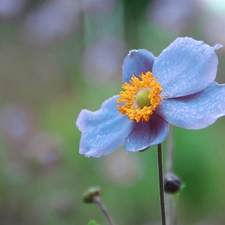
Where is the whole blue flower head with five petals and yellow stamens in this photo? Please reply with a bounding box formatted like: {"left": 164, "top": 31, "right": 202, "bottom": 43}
{"left": 76, "top": 37, "right": 225, "bottom": 157}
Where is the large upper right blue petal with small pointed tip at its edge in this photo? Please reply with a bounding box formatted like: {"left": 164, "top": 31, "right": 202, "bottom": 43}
{"left": 153, "top": 37, "right": 222, "bottom": 98}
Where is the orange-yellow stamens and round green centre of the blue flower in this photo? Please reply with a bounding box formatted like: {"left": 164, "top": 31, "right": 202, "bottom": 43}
{"left": 117, "top": 72, "right": 163, "bottom": 122}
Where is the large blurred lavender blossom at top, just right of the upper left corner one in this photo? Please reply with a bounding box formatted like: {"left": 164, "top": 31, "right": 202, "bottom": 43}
{"left": 23, "top": 0, "right": 80, "bottom": 43}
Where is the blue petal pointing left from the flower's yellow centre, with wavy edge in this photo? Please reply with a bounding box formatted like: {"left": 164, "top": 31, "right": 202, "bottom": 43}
{"left": 76, "top": 96, "right": 136, "bottom": 157}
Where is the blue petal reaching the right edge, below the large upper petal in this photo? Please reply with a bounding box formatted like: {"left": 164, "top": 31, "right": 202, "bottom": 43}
{"left": 156, "top": 82, "right": 225, "bottom": 130}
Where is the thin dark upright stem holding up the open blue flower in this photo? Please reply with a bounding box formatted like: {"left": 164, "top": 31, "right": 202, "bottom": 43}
{"left": 157, "top": 144, "right": 166, "bottom": 225}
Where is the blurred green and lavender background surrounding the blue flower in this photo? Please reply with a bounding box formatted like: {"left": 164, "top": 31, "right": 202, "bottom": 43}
{"left": 0, "top": 0, "right": 225, "bottom": 225}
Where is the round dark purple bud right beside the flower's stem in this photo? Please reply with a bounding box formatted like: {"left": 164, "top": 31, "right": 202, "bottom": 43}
{"left": 164, "top": 173, "right": 182, "bottom": 194}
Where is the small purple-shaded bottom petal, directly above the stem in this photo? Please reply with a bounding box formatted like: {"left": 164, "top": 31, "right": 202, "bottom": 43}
{"left": 125, "top": 114, "right": 169, "bottom": 152}
